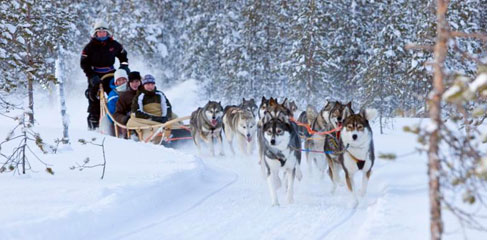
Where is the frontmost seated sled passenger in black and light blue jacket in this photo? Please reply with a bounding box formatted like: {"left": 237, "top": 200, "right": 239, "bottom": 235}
{"left": 127, "top": 74, "right": 172, "bottom": 142}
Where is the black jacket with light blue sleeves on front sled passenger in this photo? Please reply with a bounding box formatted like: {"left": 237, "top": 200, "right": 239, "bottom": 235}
{"left": 132, "top": 87, "right": 172, "bottom": 119}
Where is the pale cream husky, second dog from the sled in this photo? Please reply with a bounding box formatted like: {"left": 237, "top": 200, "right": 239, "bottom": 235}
{"left": 223, "top": 106, "right": 256, "bottom": 154}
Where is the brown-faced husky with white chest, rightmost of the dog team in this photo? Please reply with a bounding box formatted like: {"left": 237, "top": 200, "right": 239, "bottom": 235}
{"left": 342, "top": 109, "right": 377, "bottom": 205}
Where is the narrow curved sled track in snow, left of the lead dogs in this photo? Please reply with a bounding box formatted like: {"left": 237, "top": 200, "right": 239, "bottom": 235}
{"left": 113, "top": 162, "right": 240, "bottom": 239}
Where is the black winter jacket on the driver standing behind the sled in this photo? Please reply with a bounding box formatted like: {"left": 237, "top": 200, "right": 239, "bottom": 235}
{"left": 80, "top": 37, "right": 128, "bottom": 79}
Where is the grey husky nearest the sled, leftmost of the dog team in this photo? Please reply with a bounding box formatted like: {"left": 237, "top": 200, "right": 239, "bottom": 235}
{"left": 190, "top": 101, "right": 225, "bottom": 156}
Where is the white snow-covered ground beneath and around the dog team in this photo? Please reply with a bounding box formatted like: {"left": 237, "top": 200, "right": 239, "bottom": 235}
{"left": 0, "top": 81, "right": 482, "bottom": 240}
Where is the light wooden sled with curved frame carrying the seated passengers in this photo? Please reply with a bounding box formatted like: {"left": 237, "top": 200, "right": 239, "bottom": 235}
{"left": 98, "top": 73, "right": 191, "bottom": 147}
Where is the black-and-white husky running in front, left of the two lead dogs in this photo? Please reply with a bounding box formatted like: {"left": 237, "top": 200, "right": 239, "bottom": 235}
{"left": 261, "top": 112, "right": 302, "bottom": 206}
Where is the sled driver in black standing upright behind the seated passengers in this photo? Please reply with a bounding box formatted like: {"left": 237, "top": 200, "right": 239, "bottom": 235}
{"left": 80, "top": 21, "right": 130, "bottom": 130}
